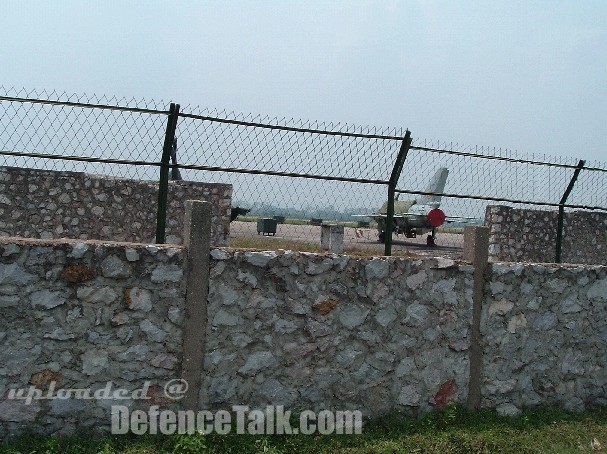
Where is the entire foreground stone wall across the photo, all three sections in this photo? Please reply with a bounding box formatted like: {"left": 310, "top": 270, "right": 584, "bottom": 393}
{"left": 0, "top": 227, "right": 607, "bottom": 437}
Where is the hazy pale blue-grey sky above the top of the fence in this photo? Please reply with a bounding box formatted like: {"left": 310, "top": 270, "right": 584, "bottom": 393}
{"left": 0, "top": 0, "right": 607, "bottom": 161}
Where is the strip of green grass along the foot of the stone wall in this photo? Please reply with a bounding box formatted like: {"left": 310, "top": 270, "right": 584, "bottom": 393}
{"left": 0, "top": 407, "right": 607, "bottom": 454}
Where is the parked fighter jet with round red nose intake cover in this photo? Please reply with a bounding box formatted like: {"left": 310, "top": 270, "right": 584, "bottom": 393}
{"left": 356, "top": 167, "right": 476, "bottom": 246}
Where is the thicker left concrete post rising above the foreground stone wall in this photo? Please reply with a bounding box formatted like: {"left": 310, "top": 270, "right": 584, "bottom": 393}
{"left": 181, "top": 200, "right": 211, "bottom": 410}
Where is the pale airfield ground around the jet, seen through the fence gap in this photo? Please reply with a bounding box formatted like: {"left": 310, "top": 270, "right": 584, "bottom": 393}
{"left": 230, "top": 221, "right": 464, "bottom": 259}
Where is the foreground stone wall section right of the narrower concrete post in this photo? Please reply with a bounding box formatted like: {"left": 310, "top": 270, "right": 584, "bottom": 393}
{"left": 481, "top": 263, "right": 607, "bottom": 412}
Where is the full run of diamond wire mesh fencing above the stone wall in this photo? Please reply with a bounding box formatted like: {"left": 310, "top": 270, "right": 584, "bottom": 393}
{"left": 0, "top": 87, "right": 607, "bottom": 257}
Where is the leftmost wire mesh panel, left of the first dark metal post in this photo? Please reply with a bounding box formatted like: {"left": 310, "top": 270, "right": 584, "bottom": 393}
{"left": 0, "top": 87, "right": 171, "bottom": 180}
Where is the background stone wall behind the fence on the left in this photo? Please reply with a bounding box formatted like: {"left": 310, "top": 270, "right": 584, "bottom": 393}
{"left": 0, "top": 167, "right": 232, "bottom": 246}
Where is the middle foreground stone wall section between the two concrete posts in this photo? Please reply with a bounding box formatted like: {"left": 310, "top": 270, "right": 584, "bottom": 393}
{"left": 202, "top": 249, "right": 472, "bottom": 416}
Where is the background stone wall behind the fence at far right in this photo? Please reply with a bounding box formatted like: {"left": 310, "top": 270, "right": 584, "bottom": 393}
{"left": 485, "top": 205, "right": 607, "bottom": 265}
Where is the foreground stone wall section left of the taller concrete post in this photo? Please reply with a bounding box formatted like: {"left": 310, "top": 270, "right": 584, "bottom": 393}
{"left": 0, "top": 238, "right": 186, "bottom": 439}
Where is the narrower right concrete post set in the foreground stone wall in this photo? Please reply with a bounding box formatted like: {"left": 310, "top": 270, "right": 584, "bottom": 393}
{"left": 464, "top": 226, "right": 489, "bottom": 410}
